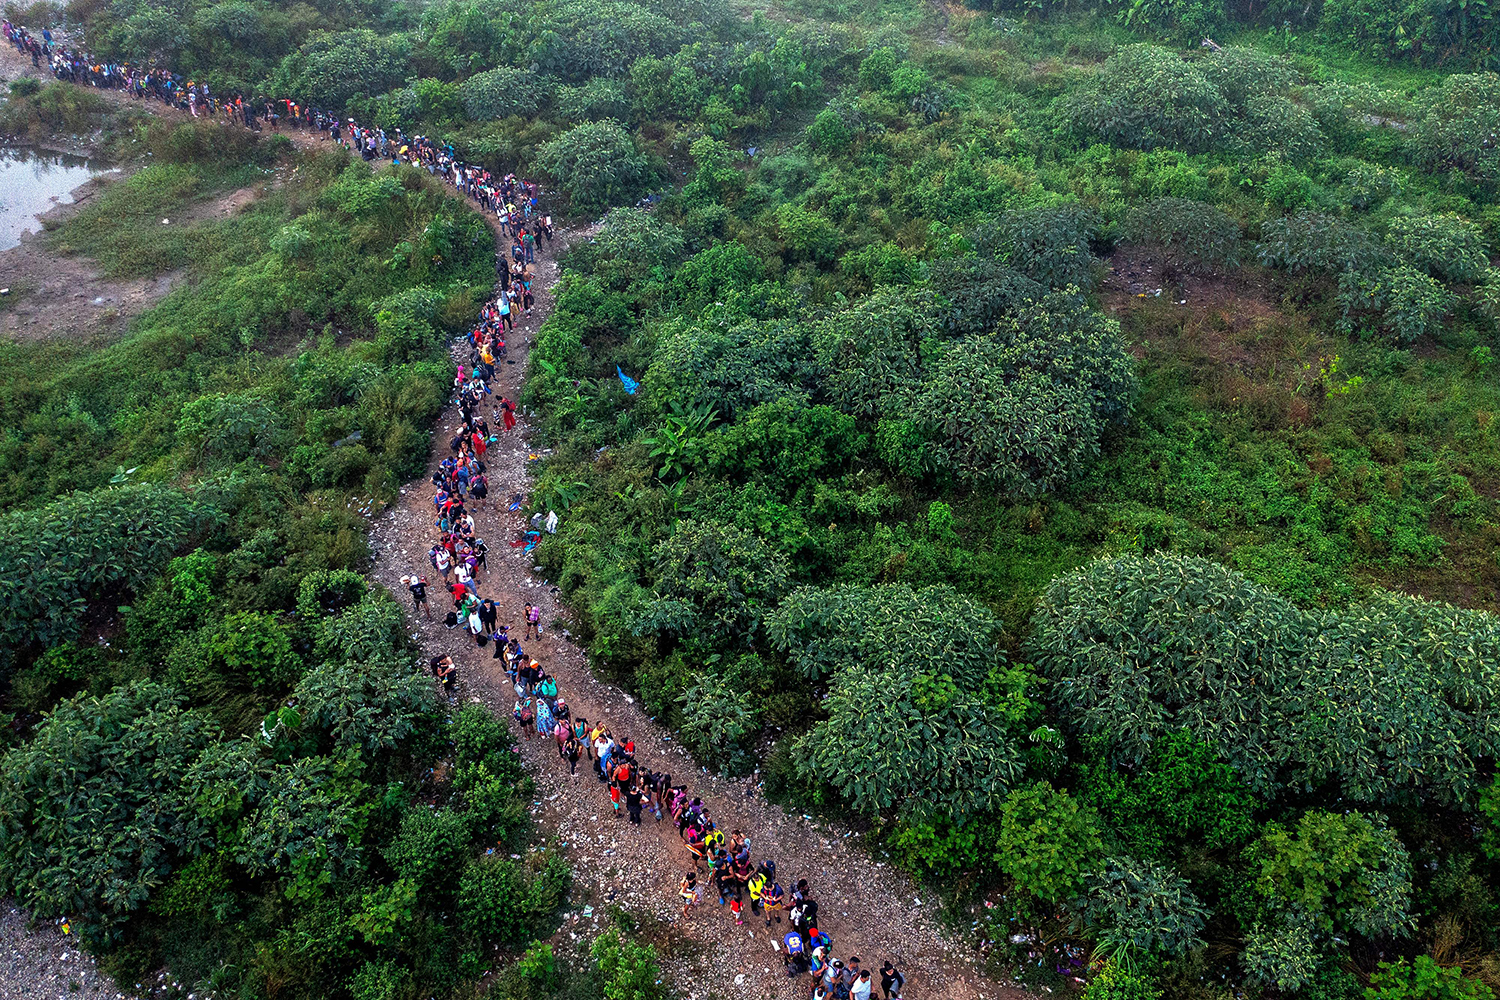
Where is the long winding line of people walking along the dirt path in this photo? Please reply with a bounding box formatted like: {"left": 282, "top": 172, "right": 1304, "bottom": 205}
{"left": 3, "top": 21, "right": 905, "bottom": 1000}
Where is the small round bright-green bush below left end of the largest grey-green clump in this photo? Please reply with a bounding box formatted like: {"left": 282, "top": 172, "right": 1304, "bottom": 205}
{"left": 995, "top": 781, "right": 1104, "bottom": 903}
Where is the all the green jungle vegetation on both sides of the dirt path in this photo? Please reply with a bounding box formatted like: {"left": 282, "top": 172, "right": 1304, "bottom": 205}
{"left": 0, "top": 0, "right": 1500, "bottom": 1000}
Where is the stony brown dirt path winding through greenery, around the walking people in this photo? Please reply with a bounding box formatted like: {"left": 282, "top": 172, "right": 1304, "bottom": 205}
{"left": 0, "top": 46, "right": 1031, "bottom": 1000}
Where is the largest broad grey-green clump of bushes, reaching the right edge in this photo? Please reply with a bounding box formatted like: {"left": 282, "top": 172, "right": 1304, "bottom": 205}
{"left": 1029, "top": 555, "right": 1500, "bottom": 805}
